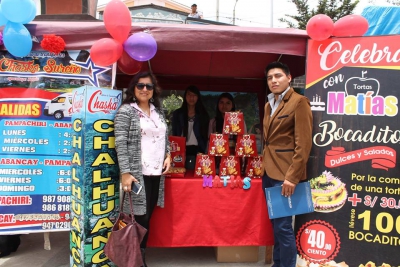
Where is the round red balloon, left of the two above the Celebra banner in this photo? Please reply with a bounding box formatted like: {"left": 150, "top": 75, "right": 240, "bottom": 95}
{"left": 306, "top": 14, "right": 333, "bottom": 41}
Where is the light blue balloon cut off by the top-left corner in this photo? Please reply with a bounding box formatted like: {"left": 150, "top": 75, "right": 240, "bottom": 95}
{"left": 1, "top": 0, "right": 36, "bottom": 23}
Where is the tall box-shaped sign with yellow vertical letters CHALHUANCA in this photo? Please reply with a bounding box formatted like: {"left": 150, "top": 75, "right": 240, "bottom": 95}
{"left": 70, "top": 86, "right": 122, "bottom": 266}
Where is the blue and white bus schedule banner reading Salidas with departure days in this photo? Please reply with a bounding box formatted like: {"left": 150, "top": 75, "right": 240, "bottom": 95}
{"left": 0, "top": 50, "right": 111, "bottom": 234}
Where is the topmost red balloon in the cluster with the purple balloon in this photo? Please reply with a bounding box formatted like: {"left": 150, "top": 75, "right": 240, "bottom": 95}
{"left": 103, "top": 0, "right": 132, "bottom": 44}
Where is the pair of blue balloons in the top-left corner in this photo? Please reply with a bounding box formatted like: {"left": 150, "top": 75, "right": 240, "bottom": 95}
{"left": 0, "top": 0, "right": 36, "bottom": 57}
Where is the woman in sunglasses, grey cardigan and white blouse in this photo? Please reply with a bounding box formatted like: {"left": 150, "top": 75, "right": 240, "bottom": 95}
{"left": 114, "top": 72, "right": 171, "bottom": 266}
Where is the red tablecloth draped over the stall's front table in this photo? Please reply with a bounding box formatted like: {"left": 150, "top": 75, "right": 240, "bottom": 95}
{"left": 148, "top": 177, "right": 273, "bottom": 247}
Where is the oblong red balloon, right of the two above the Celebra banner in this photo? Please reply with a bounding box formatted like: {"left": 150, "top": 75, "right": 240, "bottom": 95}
{"left": 333, "top": 15, "right": 369, "bottom": 37}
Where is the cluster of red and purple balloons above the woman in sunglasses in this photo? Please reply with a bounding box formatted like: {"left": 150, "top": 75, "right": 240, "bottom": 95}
{"left": 90, "top": 0, "right": 157, "bottom": 75}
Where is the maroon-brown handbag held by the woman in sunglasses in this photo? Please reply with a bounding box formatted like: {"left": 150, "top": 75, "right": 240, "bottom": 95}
{"left": 104, "top": 192, "right": 147, "bottom": 267}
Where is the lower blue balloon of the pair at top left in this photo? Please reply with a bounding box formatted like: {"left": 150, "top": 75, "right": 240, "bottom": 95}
{"left": 3, "top": 22, "right": 32, "bottom": 57}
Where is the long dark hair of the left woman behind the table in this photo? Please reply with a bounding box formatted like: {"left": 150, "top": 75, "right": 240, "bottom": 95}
{"left": 181, "top": 85, "right": 210, "bottom": 140}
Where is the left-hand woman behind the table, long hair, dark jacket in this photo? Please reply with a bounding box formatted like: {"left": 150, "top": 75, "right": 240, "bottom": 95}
{"left": 172, "top": 85, "right": 209, "bottom": 169}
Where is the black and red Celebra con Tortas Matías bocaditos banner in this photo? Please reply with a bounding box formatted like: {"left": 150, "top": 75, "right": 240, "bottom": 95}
{"left": 296, "top": 36, "right": 400, "bottom": 267}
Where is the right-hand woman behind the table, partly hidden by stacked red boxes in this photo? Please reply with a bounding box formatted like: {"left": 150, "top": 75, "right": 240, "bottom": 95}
{"left": 208, "top": 93, "right": 247, "bottom": 155}
